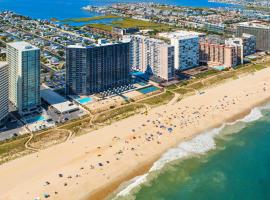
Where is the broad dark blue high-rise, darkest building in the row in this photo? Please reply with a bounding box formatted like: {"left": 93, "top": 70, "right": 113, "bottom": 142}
{"left": 66, "top": 43, "right": 130, "bottom": 95}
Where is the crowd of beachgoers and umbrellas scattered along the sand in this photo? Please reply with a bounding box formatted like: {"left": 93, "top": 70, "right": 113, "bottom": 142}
{"left": 34, "top": 83, "right": 268, "bottom": 200}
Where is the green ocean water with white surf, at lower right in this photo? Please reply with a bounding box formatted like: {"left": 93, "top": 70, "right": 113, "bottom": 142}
{"left": 112, "top": 104, "right": 270, "bottom": 200}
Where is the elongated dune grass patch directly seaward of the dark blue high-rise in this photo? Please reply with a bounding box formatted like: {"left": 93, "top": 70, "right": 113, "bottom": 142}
{"left": 93, "top": 104, "right": 144, "bottom": 123}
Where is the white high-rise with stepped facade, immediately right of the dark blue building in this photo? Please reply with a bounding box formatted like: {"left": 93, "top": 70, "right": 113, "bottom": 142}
{"left": 125, "top": 35, "right": 174, "bottom": 80}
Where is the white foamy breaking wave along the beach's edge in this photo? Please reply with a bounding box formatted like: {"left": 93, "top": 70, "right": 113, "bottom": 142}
{"left": 113, "top": 104, "right": 270, "bottom": 200}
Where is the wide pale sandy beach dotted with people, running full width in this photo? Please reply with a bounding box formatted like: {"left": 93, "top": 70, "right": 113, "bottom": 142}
{"left": 0, "top": 68, "right": 270, "bottom": 200}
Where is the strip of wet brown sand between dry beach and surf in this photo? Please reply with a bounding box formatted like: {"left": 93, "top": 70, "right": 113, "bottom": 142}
{"left": 90, "top": 97, "right": 270, "bottom": 200}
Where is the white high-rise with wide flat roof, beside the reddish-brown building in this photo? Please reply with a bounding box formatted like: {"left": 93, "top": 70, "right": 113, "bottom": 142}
{"left": 159, "top": 31, "right": 200, "bottom": 71}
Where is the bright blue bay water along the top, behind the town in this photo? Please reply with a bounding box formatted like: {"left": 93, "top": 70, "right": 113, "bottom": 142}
{"left": 0, "top": 0, "right": 231, "bottom": 20}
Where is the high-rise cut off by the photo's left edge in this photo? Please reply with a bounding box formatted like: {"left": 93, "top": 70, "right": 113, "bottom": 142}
{"left": 0, "top": 62, "right": 9, "bottom": 126}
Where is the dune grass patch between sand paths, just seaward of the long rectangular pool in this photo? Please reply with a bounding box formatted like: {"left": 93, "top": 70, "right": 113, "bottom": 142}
{"left": 140, "top": 91, "right": 174, "bottom": 106}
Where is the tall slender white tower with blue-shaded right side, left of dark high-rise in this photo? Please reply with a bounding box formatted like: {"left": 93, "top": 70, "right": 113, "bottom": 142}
{"left": 7, "top": 42, "right": 40, "bottom": 115}
